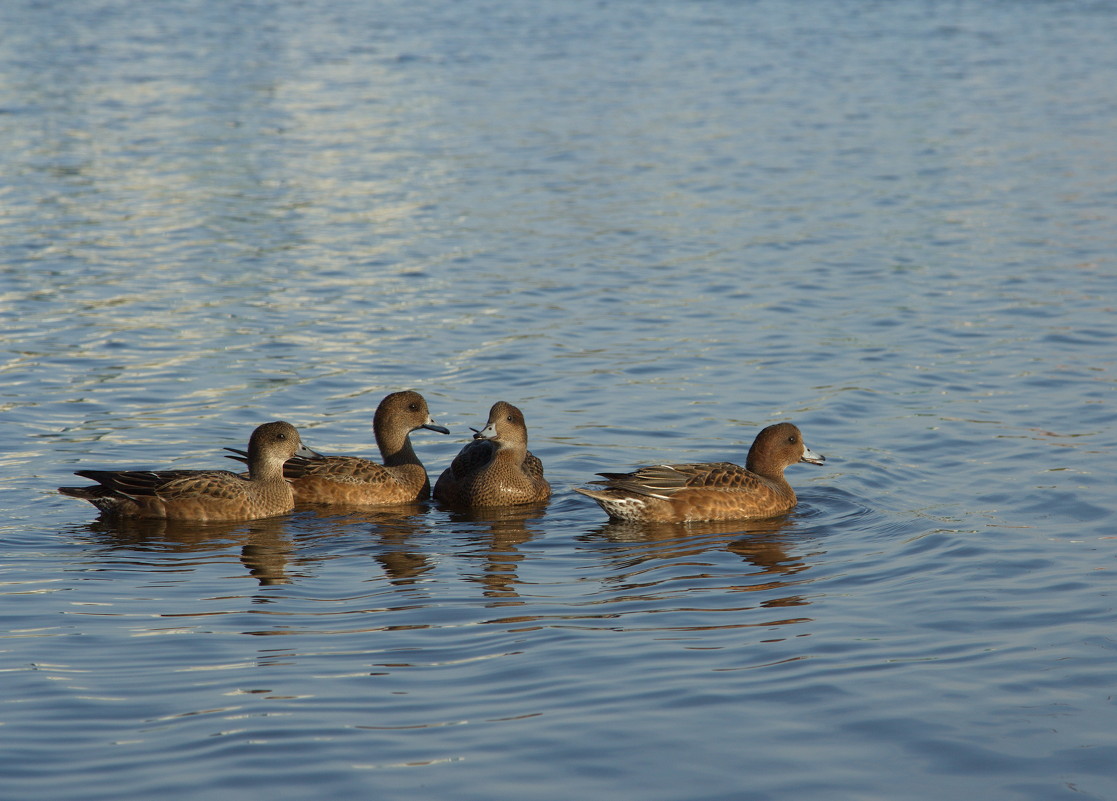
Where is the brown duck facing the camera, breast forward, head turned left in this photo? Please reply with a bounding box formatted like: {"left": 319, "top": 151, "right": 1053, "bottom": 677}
{"left": 435, "top": 401, "right": 551, "bottom": 508}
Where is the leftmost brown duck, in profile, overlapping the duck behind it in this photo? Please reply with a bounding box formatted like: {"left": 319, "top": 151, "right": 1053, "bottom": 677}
{"left": 58, "top": 420, "right": 319, "bottom": 523}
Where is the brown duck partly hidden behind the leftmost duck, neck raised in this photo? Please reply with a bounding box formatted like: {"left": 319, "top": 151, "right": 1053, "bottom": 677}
{"left": 227, "top": 390, "right": 450, "bottom": 506}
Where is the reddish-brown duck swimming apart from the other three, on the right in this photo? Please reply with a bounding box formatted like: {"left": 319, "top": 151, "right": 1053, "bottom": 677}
{"left": 574, "top": 422, "right": 825, "bottom": 523}
